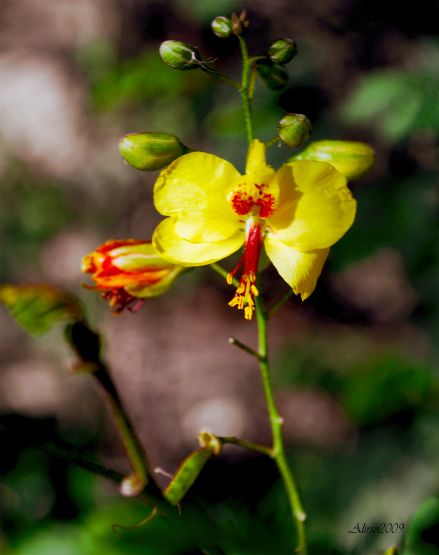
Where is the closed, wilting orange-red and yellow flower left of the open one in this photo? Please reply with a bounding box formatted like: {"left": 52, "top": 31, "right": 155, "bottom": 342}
{"left": 82, "top": 239, "right": 183, "bottom": 312}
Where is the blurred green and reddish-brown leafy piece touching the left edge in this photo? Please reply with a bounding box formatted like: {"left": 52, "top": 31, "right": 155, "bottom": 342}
{"left": 0, "top": 284, "right": 84, "bottom": 334}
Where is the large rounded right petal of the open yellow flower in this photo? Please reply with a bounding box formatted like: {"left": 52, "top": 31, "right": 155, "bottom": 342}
{"left": 269, "top": 160, "right": 356, "bottom": 251}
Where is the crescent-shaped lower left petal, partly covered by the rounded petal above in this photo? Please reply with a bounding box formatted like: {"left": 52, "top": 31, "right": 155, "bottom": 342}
{"left": 152, "top": 218, "right": 245, "bottom": 266}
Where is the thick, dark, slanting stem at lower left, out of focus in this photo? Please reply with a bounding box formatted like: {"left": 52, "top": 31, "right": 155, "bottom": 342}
{"left": 93, "top": 365, "right": 148, "bottom": 486}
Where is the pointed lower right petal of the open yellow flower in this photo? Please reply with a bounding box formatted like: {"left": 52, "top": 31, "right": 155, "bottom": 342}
{"left": 264, "top": 235, "right": 329, "bottom": 301}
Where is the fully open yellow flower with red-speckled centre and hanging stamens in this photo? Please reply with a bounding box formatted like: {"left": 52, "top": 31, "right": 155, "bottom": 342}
{"left": 152, "top": 140, "right": 356, "bottom": 319}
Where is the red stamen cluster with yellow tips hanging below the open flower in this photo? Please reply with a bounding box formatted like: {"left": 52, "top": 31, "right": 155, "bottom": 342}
{"left": 227, "top": 217, "right": 262, "bottom": 320}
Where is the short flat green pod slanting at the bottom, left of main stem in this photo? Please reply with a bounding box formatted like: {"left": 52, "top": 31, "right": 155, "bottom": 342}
{"left": 163, "top": 447, "right": 213, "bottom": 505}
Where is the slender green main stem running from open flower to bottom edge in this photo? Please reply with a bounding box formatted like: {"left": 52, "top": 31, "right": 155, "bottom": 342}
{"left": 255, "top": 294, "right": 307, "bottom": 555}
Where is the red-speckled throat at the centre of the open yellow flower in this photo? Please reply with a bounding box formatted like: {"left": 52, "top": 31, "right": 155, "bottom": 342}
{"left": 228, "top": 180, "right": 276, "bottom": 218}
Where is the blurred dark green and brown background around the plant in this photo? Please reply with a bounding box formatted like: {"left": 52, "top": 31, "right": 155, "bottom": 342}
{"left": 0, "top": 0, "right": 439, "bottom": 555}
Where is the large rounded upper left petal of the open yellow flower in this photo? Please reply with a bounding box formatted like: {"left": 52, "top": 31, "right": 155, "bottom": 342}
{"left": 154, "top": 152, "right": 240, "bottom": 241}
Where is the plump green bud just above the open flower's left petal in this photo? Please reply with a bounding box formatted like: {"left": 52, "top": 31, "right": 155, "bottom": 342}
{"left": 119, "top": 133, "right": 188, "bottom": 170}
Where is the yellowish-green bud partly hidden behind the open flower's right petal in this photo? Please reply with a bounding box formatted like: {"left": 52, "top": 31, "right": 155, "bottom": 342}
{"left": 289, "top": 141, "right": 375, "bottom": 180}
